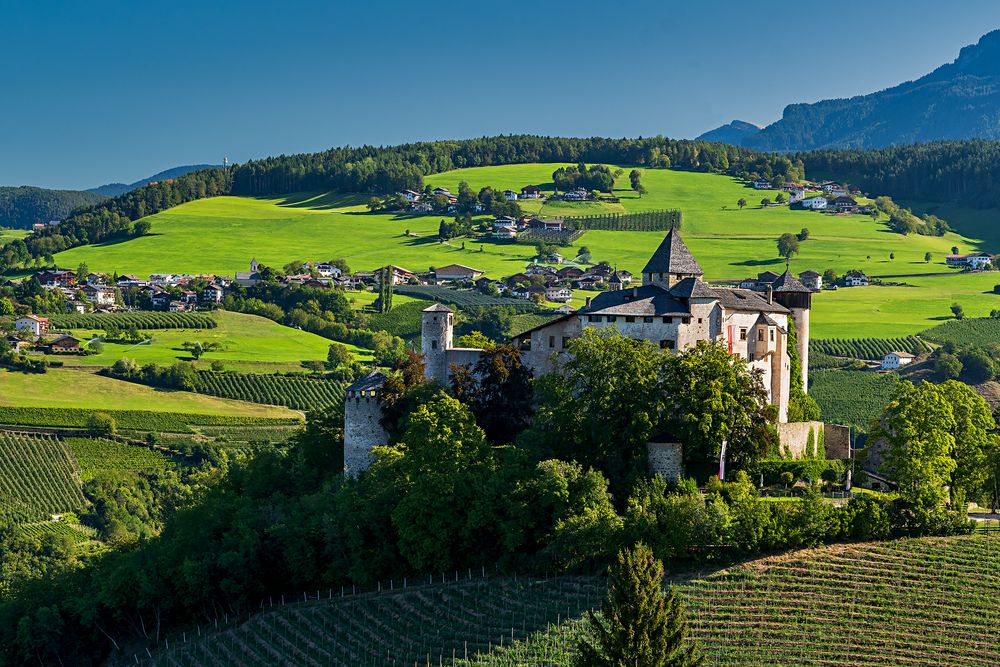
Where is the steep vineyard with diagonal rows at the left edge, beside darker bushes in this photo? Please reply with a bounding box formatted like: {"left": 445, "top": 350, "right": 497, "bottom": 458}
{"left": 0, "top": 431, "right": 87, "bottom": 522}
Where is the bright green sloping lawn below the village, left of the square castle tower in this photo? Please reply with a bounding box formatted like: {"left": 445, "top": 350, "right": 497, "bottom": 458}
{"left": 48, "top": 310, "right": 371, "bottom": 372}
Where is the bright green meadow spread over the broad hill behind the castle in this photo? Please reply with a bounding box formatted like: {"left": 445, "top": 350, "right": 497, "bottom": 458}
{"left": 48, "top": 164, "right": 1000, "bottom": 337}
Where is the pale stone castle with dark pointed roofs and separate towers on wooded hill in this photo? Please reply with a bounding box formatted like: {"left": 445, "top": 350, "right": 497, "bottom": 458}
{"left": 344, "top": 230, "right": 812, "bottom": 472}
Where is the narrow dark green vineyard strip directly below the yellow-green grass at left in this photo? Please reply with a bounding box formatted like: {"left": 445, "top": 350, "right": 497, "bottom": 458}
{"left": 0, "top": 407, "right": 300, "bottom": 433}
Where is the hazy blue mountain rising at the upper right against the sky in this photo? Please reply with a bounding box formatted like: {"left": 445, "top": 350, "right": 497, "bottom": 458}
{"left": 698, "top": 30, "right": 1000, "bottom": 151}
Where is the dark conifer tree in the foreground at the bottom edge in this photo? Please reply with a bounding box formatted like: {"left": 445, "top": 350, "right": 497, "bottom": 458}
{"left": 575, "top": 543, "right": 704, "bottom": 667}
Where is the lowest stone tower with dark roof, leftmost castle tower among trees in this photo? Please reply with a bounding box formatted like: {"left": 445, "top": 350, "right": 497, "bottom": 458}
{"left": 344, "top": 371, "right": 389, "bottom": 477}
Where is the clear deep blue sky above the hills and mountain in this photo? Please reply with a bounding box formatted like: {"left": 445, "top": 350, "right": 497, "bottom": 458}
{"left": 0, "top": 0, "right": 1000, "bottom": 188}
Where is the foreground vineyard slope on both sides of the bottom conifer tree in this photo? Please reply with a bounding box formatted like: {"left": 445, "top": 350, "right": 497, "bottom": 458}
{"left": 131, "top": 534, "right": 1000, "bottom": 667}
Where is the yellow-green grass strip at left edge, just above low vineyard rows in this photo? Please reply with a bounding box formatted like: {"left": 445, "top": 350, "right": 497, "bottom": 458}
{"left": 0, "top": 368, "right": 299, "bottom": 418}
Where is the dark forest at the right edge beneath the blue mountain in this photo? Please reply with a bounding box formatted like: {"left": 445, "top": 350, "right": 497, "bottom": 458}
{"left": 794, "top": 140, "right": 1000, "bottom": 208}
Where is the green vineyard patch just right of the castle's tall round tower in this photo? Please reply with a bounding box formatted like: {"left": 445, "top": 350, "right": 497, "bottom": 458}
{"left": 809, "top": 370, "right": 900, "bottom": 431}
